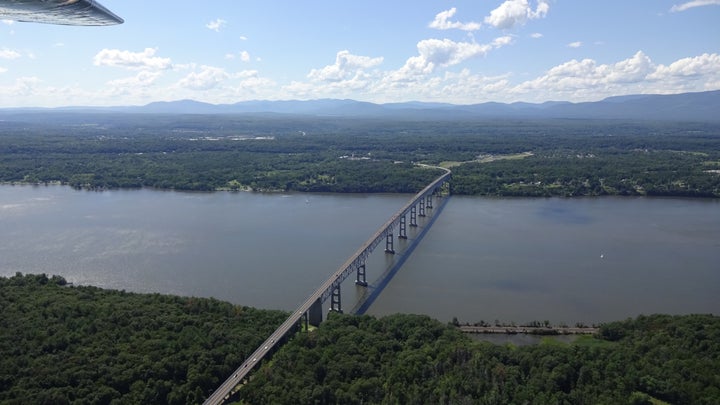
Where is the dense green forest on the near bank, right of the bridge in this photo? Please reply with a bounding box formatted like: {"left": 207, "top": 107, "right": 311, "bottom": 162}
{"left": 239, "top": 315, "right": 720, "bottom": 405}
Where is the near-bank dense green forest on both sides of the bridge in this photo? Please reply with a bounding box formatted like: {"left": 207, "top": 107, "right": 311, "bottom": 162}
{"left": 0, "top": 274, "right": 720, "bottom": 404}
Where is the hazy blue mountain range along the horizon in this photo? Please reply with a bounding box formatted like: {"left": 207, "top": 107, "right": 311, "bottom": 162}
{"left": 0, "top": 90, "right": 720, "bottom": 121}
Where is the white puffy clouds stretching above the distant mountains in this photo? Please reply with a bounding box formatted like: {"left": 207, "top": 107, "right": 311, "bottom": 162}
{"left": 0, "top": 0, "right": 720, "bottom": 105}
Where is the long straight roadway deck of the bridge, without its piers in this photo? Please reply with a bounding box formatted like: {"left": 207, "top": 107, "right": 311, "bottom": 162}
{"left": 203, "top": 169, "right": 451, "bottom": 405}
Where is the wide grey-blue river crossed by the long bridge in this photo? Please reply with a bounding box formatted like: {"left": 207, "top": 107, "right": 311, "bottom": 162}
{"left": 0, "top": 185, "right": 720, "bottom": 323}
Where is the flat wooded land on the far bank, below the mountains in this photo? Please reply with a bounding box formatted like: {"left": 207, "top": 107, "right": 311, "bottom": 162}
{"left": 0, "top": 113, "right": 720, "bottom": 197}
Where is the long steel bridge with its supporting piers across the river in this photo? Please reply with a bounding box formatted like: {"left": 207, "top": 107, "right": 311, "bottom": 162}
{"left": 204, "top": 169, "right": 451, "bottom": 405}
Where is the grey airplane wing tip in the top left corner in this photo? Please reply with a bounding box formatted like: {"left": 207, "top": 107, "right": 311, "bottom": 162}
{"left": 0, "top": 0, "right": 124, "bottom": 25}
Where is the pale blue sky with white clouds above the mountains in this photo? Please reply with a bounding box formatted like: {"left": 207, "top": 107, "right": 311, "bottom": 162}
{"left": 0, "top": 0, "right": 720, "bottom": 107}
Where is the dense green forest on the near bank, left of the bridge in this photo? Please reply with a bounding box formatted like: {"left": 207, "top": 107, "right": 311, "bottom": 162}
{"left": 0, "top": 275, "right": 287, "bottom": 405}
